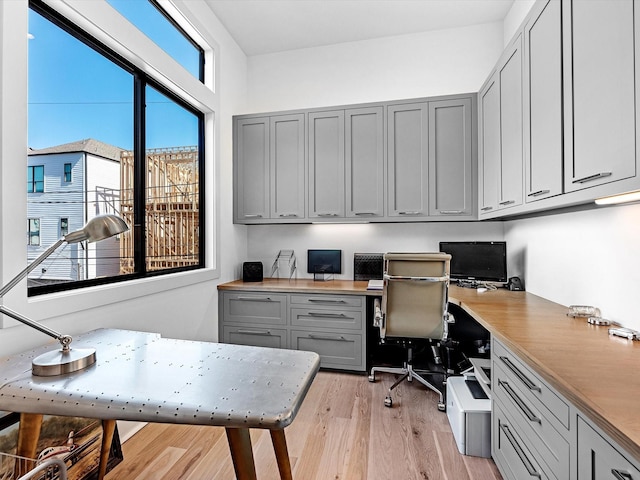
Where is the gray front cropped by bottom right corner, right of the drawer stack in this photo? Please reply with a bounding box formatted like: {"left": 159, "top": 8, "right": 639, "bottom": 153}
{"left": 578, "top": 416, "right": 640, "bottom": 480}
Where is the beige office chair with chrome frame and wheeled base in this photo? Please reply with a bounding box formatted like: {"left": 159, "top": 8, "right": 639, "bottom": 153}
{"left": 369, "top": 253, "right": 454, "bottom": 411}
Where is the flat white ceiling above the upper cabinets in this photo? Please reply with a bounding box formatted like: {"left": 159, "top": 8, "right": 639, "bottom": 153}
{"left": 206, "top": 0, "right": 514, "bottom": 56}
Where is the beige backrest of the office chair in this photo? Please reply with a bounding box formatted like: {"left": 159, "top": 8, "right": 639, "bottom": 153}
{"left": 380, "top": 253, "right": 451, "bottom": 340}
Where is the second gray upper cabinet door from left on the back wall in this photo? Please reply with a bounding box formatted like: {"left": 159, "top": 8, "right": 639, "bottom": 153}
{"left": 270, "top": 113, "right": 305, "bottom": 220}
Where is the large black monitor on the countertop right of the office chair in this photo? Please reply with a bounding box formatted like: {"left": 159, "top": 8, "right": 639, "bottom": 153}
{"left": 440, "top": 242, "right": 507, "bottom": 283}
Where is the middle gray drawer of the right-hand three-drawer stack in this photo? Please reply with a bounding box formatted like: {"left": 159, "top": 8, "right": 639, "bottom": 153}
{"left": 491, "top": 363, "right": 571, "bottom": 478}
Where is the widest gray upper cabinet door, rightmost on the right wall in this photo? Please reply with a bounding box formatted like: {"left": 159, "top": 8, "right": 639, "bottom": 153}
{"left": 563, "top": 0, "right": 636, "bottom": 191}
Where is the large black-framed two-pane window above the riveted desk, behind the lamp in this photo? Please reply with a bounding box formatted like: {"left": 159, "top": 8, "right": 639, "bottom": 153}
{"left": 27, "top": 0, "right": 205, "bottom": 295}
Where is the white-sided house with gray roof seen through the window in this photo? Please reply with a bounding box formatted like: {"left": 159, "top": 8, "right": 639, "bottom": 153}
{"left": 27, "top": 139, "right": 122, "bottom": 286}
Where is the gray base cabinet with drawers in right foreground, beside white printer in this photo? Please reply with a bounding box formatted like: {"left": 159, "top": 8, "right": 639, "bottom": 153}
{"left": 491, "top": 338, "right": 640, "bottom": 480}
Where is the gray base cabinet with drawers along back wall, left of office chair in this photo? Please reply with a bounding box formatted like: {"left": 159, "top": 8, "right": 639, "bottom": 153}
{"left": 218, "top": 291, "right": 366, "bottom": 371}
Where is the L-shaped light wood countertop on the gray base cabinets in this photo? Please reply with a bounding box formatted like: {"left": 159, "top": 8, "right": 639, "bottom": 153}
{"left": 218, "top": 279, "right": 640, "bottom": 462}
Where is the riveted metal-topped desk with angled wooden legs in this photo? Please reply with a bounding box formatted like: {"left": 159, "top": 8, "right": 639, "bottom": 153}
{"left": 0, "top": 329, "right": 320, "bottom": 480}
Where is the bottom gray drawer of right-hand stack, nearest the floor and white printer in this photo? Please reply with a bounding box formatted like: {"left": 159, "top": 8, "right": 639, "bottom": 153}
{"left": 491, "top": 402, "right": 552, "bottom": 480}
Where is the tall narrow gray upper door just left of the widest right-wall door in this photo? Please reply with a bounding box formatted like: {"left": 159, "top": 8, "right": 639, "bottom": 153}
{"left": 524, "top": 0, "right": 560, "bottom": 202}
